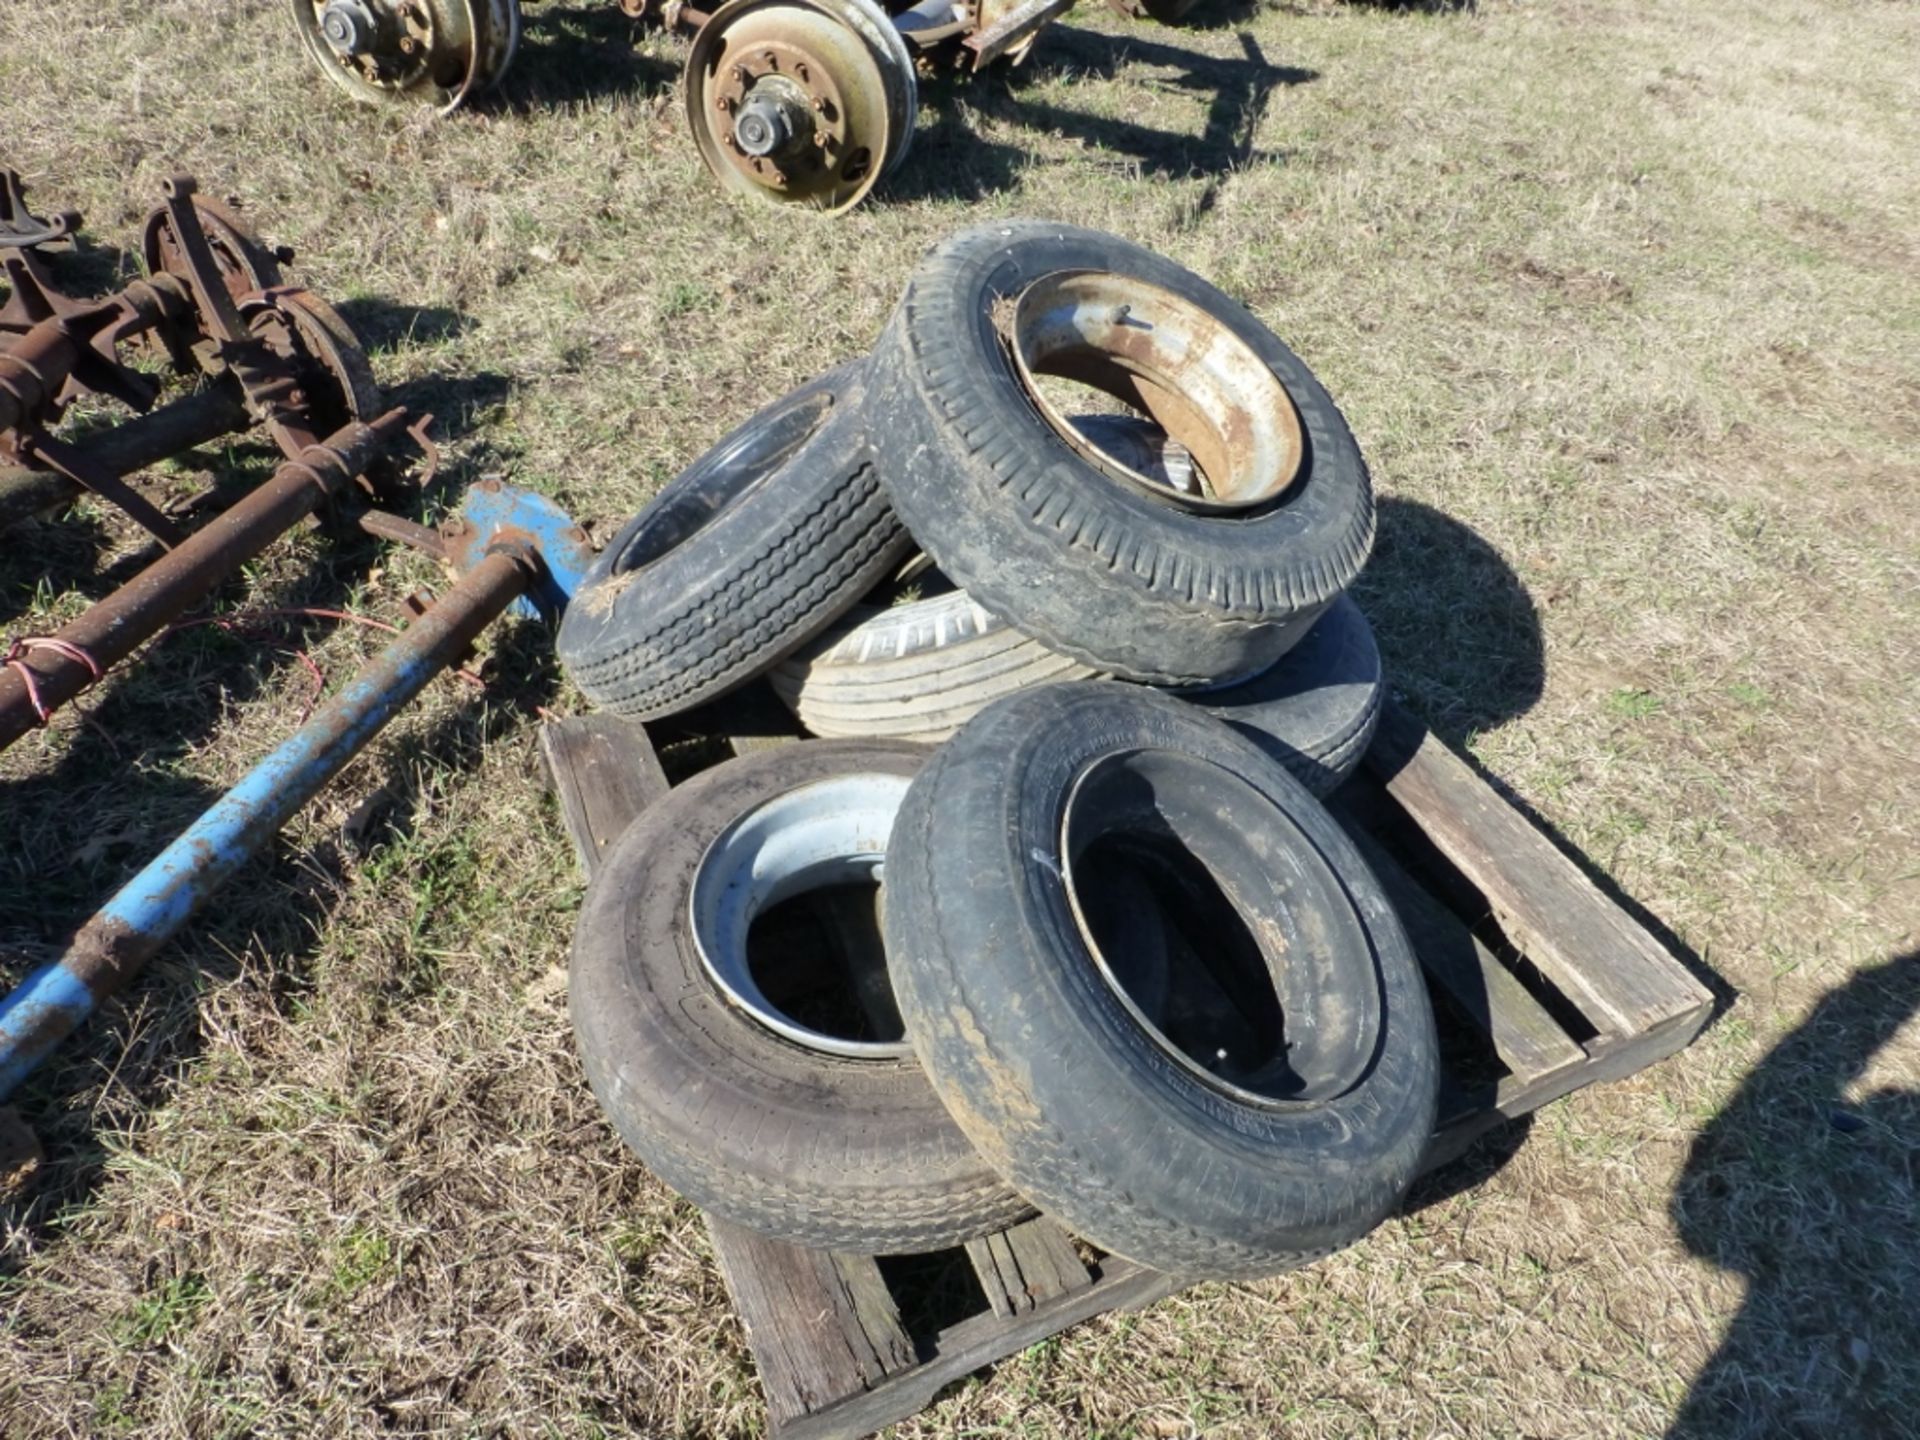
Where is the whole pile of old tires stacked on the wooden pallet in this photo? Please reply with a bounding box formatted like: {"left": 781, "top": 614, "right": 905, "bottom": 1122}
{"left": 561, "top": 221, "right": 1438, "bottom": 1277}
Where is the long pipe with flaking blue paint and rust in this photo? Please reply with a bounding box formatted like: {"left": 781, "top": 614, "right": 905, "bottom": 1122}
{"left": 0, "top": 540, "right": 541, "bottom": 1100}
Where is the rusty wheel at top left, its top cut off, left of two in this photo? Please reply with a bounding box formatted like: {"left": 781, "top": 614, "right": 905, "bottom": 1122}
{"left": 290, "top": 0, "right": 520, "bottom": 111}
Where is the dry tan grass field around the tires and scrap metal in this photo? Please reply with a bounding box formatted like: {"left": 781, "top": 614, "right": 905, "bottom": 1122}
{"left": 0, "top": 0, "right": 1920, "bottom": 1440}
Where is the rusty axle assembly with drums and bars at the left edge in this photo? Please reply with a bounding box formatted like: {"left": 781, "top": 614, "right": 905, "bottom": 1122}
{"left": 0, "top": 173, "right": 389, "bottom": 749}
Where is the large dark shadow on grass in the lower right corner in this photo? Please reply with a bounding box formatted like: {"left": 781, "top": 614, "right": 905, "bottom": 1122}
{"left": 1668, "top": 950, "right": 1920, "bottom": 1440}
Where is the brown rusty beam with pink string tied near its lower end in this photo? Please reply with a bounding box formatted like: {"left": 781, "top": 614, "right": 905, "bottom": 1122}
{"left": 0, "top": 409, "right": 407, "bottom": 749}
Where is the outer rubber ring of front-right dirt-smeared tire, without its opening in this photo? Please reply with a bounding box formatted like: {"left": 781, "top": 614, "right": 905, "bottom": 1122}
{"left": 889, "top": 684, "right": 1438, "bottom": 1273}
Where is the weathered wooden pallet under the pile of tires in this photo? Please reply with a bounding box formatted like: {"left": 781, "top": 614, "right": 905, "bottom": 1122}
{"left": 541, "top": 707, "right": 1713, "bottom": 1440}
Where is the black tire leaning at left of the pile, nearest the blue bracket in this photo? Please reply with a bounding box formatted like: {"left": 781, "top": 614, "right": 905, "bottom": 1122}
{"left": 557, "top": 361, "right": 912, "bottom": 720}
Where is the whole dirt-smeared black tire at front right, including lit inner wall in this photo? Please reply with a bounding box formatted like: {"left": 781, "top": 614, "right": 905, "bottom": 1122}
{"left": 885, "top": 682, "right": 1438, "bottom": 1277}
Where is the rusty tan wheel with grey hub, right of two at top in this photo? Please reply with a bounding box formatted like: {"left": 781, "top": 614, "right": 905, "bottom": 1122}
{"left": 687, "top": 0, "right": 918, "bottom": 213}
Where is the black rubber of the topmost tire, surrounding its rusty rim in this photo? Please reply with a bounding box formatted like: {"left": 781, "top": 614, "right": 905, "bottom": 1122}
{"left": 868, "top": 221, "right": 1373, "bottom": 685}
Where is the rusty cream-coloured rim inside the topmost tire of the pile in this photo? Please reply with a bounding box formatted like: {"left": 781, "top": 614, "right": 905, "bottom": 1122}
{"left": 1000, "top": 271, "right": 1306, "bottom": 513}
